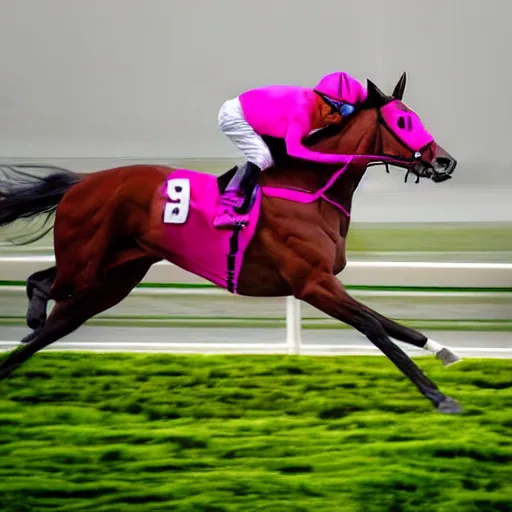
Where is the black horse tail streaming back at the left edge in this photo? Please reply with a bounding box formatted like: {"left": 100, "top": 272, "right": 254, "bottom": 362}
{"left": 0, "top": 164, "right": 83, "bottom": 245}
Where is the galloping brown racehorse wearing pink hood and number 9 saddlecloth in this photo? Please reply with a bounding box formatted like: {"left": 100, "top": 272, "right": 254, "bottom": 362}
{"left": 0, "top": 74, "right": 461, "bottom": 413}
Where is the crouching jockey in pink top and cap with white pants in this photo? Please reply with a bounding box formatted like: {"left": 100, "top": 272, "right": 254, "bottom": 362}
{"left": 214, "top": 72, "right": 366, "bottom": 228}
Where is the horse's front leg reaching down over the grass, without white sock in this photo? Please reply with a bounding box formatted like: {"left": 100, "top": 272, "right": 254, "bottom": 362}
{"left": 292, "top": 271, "right": 461, "bottom": 413}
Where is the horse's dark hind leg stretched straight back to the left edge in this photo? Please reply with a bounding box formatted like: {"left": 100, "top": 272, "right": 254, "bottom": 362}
{"left": 0, "top": 255, "right": 157, "bottom": 379}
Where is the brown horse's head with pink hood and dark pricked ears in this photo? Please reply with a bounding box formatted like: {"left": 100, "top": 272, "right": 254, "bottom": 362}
{"left": 310, "top": 73, "right": 457, "bottom": 182}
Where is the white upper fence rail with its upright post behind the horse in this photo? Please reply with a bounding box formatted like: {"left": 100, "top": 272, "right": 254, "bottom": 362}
{"left": 0, "top": 255, "right": 512, "bottom": 354}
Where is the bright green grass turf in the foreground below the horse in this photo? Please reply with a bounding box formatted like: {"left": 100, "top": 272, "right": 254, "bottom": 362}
{"left": 0, "top": 352, "right": 512, "bottom": 512}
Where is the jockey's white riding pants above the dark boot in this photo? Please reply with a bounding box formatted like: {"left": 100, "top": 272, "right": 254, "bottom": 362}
{"left": 217, "top": 96, "right": 274, "bottom": 171}
